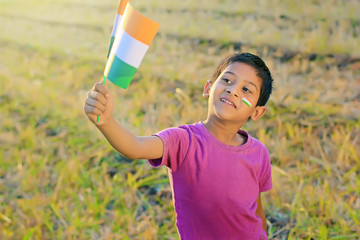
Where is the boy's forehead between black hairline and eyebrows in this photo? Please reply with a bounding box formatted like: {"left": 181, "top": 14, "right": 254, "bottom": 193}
{"left": 221, "top": 62, "right": 261, "bottom": 86}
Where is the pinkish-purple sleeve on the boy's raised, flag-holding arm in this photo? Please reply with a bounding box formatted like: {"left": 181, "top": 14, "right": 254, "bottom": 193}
{"left": 148, "top": 128, "right": 190, "bottom": 172}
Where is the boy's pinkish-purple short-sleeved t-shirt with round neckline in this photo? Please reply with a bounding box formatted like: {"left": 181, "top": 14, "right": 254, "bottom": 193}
{"left": 149, "top": 122, "right": 272, "bottom": 240}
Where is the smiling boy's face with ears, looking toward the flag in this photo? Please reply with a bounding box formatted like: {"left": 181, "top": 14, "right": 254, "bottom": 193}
{"left": 204, "top": 62, "right": 265, "bottom": 124}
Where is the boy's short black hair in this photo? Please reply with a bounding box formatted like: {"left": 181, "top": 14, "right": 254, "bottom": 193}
{"left": 211, "top": 53, "right": 273, "bottom": 106}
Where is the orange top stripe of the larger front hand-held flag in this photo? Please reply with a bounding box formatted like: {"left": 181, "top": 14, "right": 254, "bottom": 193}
{"left": 120, "top": 3, "right": 160, "bottom": 46}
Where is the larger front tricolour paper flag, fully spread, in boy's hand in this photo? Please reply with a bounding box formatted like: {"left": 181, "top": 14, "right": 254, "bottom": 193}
{"left": 104, "top": 3, "right": 160, "bottom": 88}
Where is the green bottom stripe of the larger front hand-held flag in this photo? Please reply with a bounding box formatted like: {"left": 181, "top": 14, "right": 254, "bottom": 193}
{"left": 106, "top": 56, "right": 137, "bottom": 89}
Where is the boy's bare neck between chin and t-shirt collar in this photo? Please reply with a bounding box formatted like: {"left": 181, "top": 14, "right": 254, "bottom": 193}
{"left": 203, "top": 117, "right": 245, "bottom": 146}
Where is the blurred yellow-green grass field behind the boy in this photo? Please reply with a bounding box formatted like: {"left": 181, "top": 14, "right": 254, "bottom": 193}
{"left": 0, "top": 0, "right": 360, "bottom": 240}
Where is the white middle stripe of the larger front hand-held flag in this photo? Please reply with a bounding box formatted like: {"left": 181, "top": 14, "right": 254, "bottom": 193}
{"left": 111, "top": 29, "right": 149, "bottom": 68}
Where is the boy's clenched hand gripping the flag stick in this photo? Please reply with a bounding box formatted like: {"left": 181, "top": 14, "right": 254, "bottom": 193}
{"left": 84, "top": 82, "right": 114, "bottom": 126}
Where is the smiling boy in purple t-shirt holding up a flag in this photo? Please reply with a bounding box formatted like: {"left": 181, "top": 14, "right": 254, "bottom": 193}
{"left": 84, "top": 53, "right": 273, "bottom": 240}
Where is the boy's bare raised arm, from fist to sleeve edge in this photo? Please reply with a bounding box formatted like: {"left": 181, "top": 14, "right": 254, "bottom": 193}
{"left": 84, "top": 83, "right": 163, "bottom": 159}
